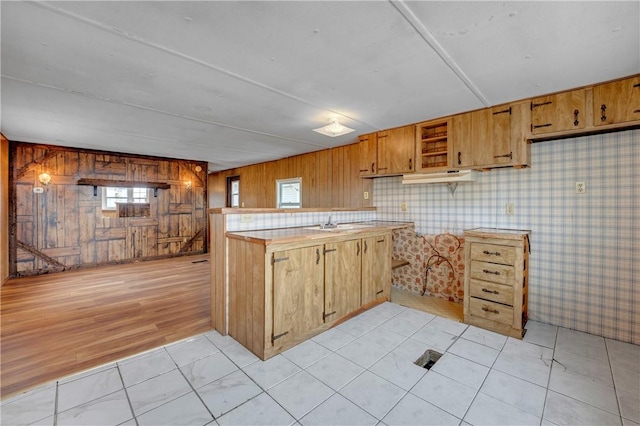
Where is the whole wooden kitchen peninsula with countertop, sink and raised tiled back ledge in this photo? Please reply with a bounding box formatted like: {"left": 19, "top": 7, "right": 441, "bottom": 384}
{"left": 210, "top": 208, "right": 413, "bottom": 359}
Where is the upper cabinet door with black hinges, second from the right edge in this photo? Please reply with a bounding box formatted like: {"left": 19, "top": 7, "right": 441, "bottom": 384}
{"left": 531, "top": 89, "right": 585, "bottom": 135}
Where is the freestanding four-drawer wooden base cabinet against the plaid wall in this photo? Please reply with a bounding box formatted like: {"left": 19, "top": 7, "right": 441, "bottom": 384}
{"left": 464, "top": 228, "right": 529, "bottom": 339}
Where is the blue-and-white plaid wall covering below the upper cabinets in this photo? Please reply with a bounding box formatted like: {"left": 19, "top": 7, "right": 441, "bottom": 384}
{"left": 373, "top": 130, "right": 640, "bottom": 344}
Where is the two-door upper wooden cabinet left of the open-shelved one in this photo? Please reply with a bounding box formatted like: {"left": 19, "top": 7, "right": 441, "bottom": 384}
{"left": 359, "top": 125, "right": 415, "bottom": 177}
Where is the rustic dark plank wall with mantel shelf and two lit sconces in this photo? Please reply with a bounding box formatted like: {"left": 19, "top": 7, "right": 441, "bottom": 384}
{"left": 9, "top": 142, "right": 207, "bottom": 276}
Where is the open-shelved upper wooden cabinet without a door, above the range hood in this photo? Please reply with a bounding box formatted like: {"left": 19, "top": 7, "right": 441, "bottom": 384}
{"left": 415, "top": 119, "right": 451, "bottom": 173}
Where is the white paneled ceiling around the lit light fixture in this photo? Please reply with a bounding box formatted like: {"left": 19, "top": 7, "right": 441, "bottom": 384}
{"left": 0, "top": 1, "right": 640, "bottom": 170}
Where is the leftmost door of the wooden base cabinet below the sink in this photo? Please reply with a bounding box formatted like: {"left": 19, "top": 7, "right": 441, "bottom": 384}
{"left": 271, "top": 246, "right": 324, "bottom": 345}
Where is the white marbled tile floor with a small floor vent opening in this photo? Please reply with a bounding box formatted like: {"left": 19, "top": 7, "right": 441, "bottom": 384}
{"left": 1, "top": 303, "right": 640, "bottom": 426}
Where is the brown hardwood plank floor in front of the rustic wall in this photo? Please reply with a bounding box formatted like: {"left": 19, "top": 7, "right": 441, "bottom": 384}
{"left": 0, "top": 254, "right": 211, "bottom": 399}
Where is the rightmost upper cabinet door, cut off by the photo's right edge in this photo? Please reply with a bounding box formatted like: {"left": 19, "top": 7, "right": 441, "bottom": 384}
{"left": 593, "top": 76, "right": 640, "bottom": 126}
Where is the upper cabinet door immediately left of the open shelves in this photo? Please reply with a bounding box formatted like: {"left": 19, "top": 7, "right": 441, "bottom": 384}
{"left": 378, "top": 125, "right": 415, "bottom": 175}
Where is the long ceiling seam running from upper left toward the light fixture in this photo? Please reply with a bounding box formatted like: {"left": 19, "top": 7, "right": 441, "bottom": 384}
{"left": 32, "top": 1, "right": 376, "bottom": 129}
